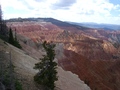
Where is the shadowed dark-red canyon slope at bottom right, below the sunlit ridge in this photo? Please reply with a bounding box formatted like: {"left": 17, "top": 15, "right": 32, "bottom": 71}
{"left": 59, "top": 50, "right": 120, "bottom": 90}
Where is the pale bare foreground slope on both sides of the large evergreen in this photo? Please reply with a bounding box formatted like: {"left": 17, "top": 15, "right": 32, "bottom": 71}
{"left": 0, "top": 40, "right": 90, "bottom": 90}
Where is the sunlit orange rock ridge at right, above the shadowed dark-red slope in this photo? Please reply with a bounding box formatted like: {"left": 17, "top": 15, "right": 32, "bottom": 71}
{"left": 64, "top": 40, "right": 117, "bottom": 60}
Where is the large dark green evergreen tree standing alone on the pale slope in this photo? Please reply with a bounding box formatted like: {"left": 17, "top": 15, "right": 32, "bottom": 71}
{"left": 34, "top": 41, "right": 58, "bottom": 90}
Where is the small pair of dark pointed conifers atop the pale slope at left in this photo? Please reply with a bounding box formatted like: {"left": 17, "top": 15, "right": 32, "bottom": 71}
{"left": 8, "top": 28, "right": 22, "bottom": 49}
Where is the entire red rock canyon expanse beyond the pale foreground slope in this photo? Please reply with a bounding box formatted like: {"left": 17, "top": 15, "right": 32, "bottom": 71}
{"left": 7, "top": 21, "right": 120, "bottom": 90}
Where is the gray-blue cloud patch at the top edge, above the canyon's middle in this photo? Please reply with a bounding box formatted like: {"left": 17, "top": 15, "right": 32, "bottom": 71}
{"left": 52, "top": 0, "right": 77, "bottom": 9}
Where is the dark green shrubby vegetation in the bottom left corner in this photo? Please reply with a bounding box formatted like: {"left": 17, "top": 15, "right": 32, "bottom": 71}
{"left": 0, "top": 55, "right": 23, "bottom": 90}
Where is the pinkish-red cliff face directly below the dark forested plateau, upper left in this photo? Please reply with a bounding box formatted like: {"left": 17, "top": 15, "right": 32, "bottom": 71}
{"left": 7, "top": 22, "right": 62, "bottom": 42}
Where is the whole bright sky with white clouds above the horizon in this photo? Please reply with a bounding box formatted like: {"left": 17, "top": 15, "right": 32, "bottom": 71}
{"left": 0, "top": 0, "right": 120, "bottom": 25}
